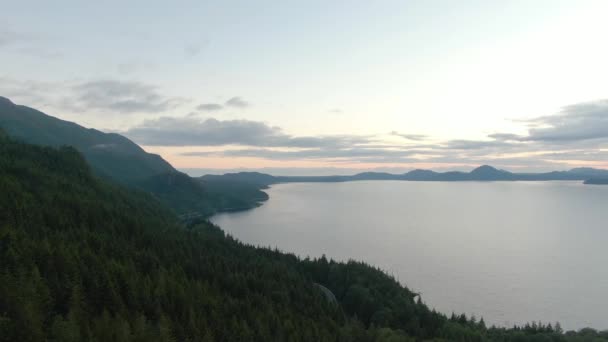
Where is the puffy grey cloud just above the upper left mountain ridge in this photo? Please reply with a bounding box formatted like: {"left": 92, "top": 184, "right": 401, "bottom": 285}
{"left": 70, "top": 80, "right": 184, "bottom": 113}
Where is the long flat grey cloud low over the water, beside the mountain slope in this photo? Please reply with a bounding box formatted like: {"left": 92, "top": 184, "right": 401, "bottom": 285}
{"left": 124, "top": 116, "right": 373, "bottom": 148}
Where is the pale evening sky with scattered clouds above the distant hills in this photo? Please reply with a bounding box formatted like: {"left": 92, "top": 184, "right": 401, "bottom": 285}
{"left": 0, "top": 0, "right": 608, "bottom": 174}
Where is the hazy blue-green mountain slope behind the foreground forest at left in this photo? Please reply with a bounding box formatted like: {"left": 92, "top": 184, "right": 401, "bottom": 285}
{"left": 0, "top": 97, "right": 247, "bottom": 216}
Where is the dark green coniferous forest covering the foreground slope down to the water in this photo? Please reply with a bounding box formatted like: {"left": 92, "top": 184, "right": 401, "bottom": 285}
{"left": 0, "top": 134, "right": 608, "bottom": 341}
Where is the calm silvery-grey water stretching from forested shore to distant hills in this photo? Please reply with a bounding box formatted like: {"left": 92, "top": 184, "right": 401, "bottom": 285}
{"left": 213, "top": 181, "right": 608, "bottom": 329}
